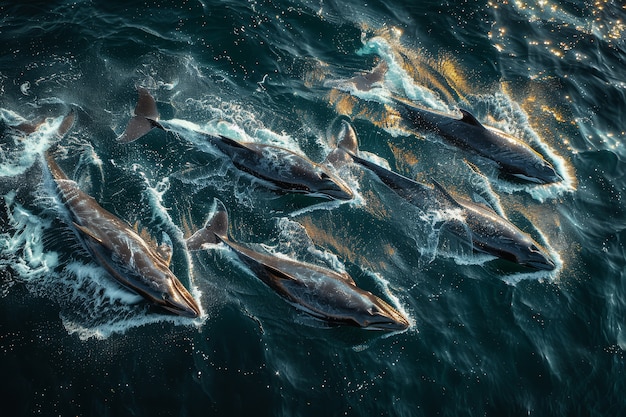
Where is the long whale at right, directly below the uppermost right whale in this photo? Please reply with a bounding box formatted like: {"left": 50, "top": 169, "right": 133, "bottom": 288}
{"left": 327, "top": 117, "right": 556, "bottom": 271}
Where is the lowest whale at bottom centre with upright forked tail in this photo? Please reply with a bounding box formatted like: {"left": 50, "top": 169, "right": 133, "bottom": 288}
{"left": 187, "top": 199, "right": 409, "bottom": 331}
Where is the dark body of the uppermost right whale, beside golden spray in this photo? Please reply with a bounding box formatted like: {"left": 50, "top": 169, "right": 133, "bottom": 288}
{"left": 390, "top": 95, "right": 563, "bottom": 184}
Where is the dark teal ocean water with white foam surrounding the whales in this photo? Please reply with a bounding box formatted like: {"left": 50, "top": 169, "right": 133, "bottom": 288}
{"left": 0, "top": 0, "right": 626, "bottom": 417}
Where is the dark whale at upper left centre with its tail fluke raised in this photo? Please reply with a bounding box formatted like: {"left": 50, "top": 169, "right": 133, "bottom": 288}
{"left": 117, "top": 87, "right": 353, "bottom": 200}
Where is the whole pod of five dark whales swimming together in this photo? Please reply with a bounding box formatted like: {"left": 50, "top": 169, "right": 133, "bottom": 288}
{"left": 9, "top": 69, "right": 560, "bottom": 324}
